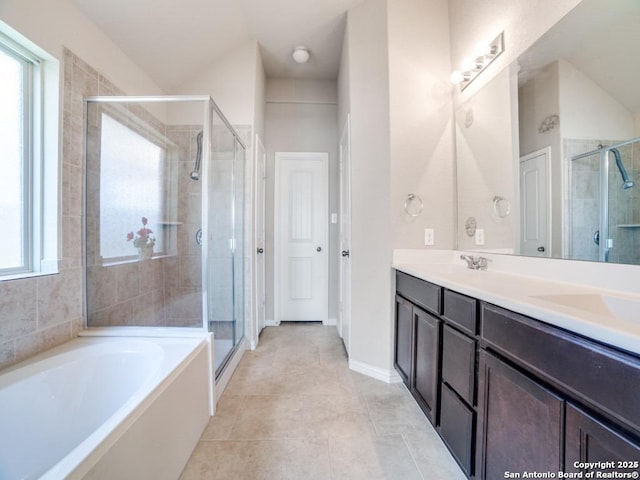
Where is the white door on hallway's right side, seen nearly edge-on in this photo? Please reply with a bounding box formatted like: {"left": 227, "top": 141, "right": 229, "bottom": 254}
{"left": 338, "top": 115, "right": 351, "bottom": 354}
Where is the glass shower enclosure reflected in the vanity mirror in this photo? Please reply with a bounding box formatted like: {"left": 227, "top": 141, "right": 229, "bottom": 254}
{"left": 568, "top": 138, "right": 640, "bottom": 265}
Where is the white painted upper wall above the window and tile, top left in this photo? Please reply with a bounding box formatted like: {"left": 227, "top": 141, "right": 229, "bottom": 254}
{"left": 0, "top": 0, "right": 163, "bottom": 95}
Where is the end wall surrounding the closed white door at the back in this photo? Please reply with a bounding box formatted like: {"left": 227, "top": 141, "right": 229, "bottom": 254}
{"left": 264, "top": 78, "right": 340, "bottom": 320}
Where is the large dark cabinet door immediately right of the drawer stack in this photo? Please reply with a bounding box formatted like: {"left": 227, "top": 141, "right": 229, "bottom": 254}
{"left": 476, "top": 351, "right": 563, "bottom": 480}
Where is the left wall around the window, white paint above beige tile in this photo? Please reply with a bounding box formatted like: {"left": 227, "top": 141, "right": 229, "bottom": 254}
{"left": 0, "top": 0, "right": 161, "bottom": 368}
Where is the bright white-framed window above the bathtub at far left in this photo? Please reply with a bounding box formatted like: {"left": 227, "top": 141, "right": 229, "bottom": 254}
{"left": 0, "top": 22, "right": 58, "bottom": 280}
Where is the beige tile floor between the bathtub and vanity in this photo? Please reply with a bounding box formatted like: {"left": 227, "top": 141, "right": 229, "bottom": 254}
{"left": 181, "top": 323, "right": 465, "bottom": 480}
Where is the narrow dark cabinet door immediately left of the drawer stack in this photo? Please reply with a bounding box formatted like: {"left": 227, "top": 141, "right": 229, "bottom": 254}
{"left": 411, "top": 307, "right": 440, "bottom": 423}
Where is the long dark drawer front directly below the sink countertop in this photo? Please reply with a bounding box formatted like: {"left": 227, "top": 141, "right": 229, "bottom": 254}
{"left": 481, "top": 303, "right": 640, "bottom": 433}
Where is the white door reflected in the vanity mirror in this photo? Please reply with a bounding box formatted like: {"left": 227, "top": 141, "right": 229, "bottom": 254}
{"left": 520, "top": 147, "right": 551, "bottom": 257}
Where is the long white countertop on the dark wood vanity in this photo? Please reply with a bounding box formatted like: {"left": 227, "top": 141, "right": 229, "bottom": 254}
{"left": 393, "top": 252, "right": 640, "bottom": 354}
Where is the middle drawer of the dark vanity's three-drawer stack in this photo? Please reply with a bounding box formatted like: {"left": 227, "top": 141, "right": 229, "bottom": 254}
{"left": 442, "top": 325, "right": 476, "bottom": 405}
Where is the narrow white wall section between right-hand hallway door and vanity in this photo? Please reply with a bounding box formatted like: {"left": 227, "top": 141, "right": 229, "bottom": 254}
{"left": 343, "top": 0, "right": 393, "bottom": 375}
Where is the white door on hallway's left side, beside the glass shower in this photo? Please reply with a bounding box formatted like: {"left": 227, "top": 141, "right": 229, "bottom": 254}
{"left": 255, "top": 134, "right": 267, "bottom": 340}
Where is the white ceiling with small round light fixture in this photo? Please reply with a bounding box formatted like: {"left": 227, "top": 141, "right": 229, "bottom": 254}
{"left": 73, "top": 0, "right": 362, "bottom": 92}
